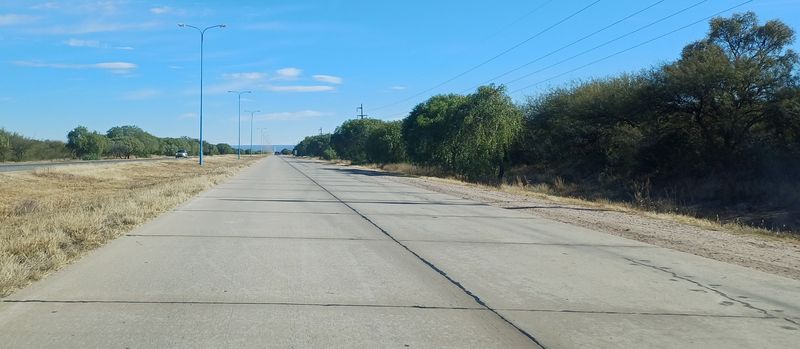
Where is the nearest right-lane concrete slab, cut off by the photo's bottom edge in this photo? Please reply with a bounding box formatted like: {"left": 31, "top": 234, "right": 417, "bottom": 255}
{"left": 501, "top": 311, "right": 800, "bottom": 349}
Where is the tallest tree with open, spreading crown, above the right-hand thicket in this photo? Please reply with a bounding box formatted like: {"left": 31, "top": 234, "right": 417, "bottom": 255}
{"left": 662, "top": 12, "right": 798, "bottom": 174}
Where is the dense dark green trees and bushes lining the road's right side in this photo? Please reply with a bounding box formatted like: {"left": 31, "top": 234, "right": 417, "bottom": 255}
{"left": 297, "top": 13, "right": 800, "bottom": 228}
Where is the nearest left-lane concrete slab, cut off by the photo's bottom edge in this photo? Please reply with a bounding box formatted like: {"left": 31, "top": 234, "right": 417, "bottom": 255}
{"left": 0, "top": 303, "right": 534, "bottom": 349}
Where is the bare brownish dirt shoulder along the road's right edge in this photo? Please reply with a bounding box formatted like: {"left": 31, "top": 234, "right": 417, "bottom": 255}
{"left": 364, "top": 166, "right": 800, "bottom": 280}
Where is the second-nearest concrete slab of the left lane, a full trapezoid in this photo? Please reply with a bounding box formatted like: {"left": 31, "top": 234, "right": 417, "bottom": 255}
{"left": 9, "top": 236, "right": 479, "bottom": 308}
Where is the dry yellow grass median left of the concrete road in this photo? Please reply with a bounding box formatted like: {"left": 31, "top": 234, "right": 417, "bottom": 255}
{"left": 0, "top": 156, "right": 259, "bottom": 297}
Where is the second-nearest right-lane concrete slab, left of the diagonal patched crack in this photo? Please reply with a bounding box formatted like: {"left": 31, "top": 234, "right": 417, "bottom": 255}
{"left": 407, "top": 242, "right": 763, "bottom": 316}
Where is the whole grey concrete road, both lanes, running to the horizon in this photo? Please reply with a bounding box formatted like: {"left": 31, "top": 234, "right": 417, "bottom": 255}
{"left": 0, "top": 157, "right": 800, "bottom": 348}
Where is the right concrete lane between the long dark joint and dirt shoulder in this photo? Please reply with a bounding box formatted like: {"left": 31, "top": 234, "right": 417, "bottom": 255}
{"left": 288, "top": 160, "right": 800, "bottom": 348}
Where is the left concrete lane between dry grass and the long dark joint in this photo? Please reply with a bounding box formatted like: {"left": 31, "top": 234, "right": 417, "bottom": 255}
{"left": 0, "top": 157, "right": 535, "bottom": 348}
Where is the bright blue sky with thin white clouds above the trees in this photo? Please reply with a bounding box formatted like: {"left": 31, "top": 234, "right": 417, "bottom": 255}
{"left": 0, "top": 0, "right": 800, "bottom": 145}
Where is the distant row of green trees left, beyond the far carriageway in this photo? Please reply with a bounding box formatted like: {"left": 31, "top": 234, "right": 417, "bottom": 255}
{"left": 0, "top": 126, "right": 242, "bottom": 162}
